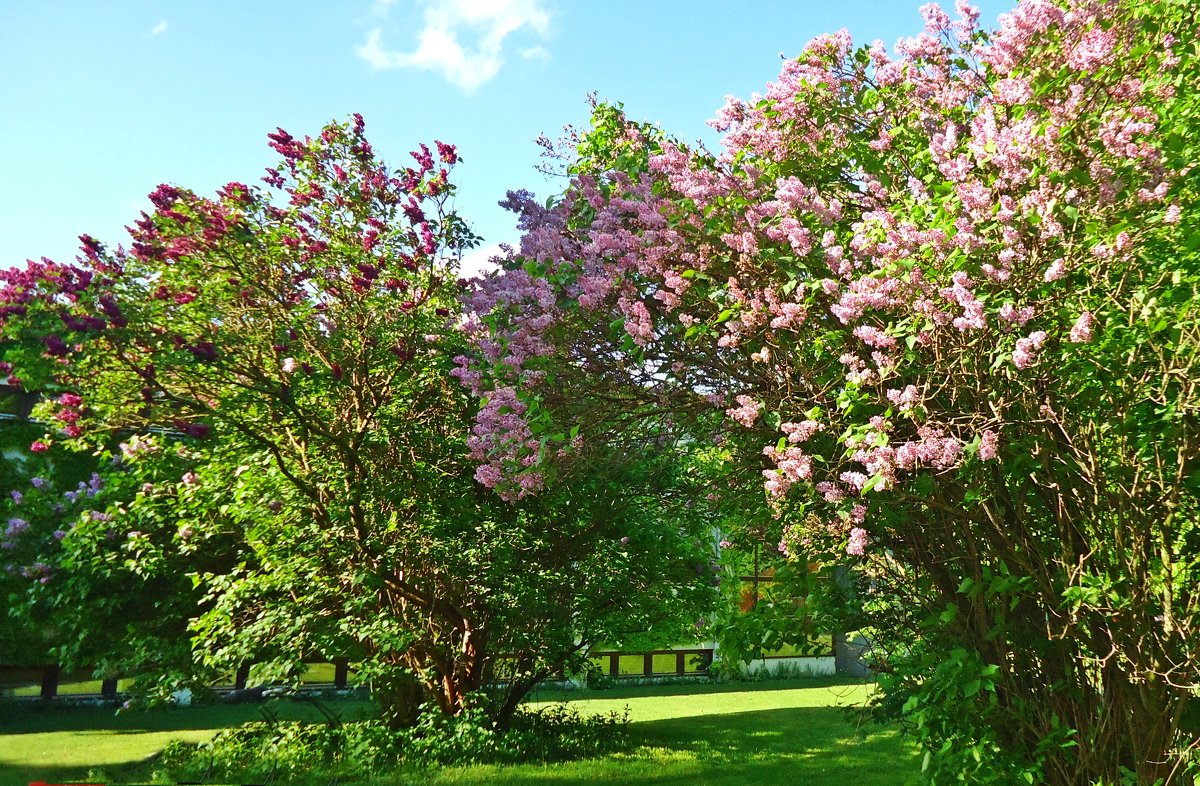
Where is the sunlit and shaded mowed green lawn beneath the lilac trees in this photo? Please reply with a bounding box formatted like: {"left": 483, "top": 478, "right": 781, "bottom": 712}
{"left": 0, "top": 680, "right": 919, "bottom": 786}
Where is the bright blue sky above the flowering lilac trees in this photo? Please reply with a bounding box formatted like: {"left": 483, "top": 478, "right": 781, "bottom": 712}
{"left": 0, "top": 0, "right": 1012, "bottom": 272}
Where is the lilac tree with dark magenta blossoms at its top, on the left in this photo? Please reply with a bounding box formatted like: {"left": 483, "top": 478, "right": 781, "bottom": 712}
{"left": 0, "top": 115, "right": 704, "bottom": 724}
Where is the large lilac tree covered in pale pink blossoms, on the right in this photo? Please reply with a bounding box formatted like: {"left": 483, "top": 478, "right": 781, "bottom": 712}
{"left": 461, "top": 0, "right": 1200, "bottom": 784}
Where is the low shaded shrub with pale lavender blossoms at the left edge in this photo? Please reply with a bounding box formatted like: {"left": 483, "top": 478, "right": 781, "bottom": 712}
{"left": 0, "top": 422, "right": 245, "bottom": 696}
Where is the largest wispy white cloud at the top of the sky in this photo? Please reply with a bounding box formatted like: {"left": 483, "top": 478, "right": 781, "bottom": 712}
{"left": 355, "top": 0, "right": 550, "bottom": 92}
